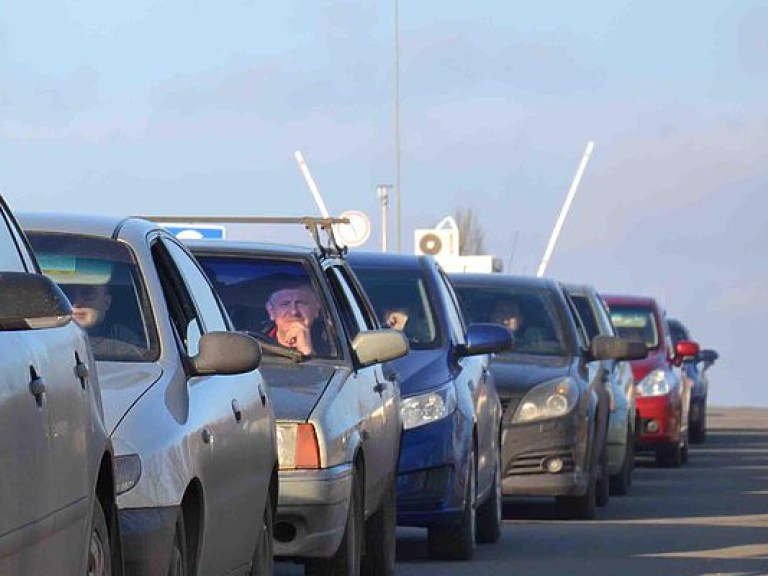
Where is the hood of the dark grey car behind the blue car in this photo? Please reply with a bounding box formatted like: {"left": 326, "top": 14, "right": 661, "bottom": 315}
{"left": 491, "top": 354, "right": 572, "bottom": 398}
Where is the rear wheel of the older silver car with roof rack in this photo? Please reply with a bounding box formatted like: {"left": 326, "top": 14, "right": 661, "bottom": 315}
{"left": 361, "top": 479, "right": 397, "bottom": 576}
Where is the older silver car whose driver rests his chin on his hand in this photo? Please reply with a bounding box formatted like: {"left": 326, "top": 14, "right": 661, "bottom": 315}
{"left": 191, "top": 241, "right": 408, "bottom": 576}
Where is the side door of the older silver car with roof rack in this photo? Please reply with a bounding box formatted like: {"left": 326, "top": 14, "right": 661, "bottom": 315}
{"left": 326, "top": 265, "right": 399, "bottom": 502}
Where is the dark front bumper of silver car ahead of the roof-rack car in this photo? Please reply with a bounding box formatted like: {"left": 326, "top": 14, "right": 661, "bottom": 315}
{"left": 118, "top": 506, "right": 179, "bottom": 576}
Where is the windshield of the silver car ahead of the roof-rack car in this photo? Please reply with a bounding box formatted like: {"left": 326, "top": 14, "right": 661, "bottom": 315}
{"left": 27, "top": 232, "right": 160, "bottom": 362}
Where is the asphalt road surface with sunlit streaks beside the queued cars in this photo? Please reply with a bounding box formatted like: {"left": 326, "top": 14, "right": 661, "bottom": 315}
{"left": 275, "top": 408, "right": 768, "bottom": 576}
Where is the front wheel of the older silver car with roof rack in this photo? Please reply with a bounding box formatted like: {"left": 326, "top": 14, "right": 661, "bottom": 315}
{"left": 304, "top": 474, "right": 364, "bottom": 576}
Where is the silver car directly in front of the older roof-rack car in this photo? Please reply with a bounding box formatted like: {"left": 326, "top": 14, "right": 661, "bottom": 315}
{"left": 22, "top": 215, "right": 278, "bottom": 576}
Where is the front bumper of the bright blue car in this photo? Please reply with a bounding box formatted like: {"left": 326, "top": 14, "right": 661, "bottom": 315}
{"left": 397, "top": 417, "right": 464, "bottom": 527}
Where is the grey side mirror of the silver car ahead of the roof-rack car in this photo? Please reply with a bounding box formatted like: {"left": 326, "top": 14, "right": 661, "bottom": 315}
{"left": 190, "top": 332, "right": 261, "bottom": 376}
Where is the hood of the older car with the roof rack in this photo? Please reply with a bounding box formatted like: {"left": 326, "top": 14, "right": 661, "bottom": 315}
{"left": 259, "top": 362, "right": 337, "bottom": 422}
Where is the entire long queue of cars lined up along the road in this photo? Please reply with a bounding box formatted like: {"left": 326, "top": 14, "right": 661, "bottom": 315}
{"left": 0, "top": 192, "right": 717, "bottom": 576}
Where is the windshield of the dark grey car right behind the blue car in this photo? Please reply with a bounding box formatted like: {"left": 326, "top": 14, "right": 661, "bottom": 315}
{"left": 454, "top": 283, "right": 567, "bottom": 356}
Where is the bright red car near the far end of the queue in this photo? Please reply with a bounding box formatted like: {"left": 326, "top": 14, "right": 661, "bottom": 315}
{"left": 603, "top": 295, "right": 699, "bottom": 468}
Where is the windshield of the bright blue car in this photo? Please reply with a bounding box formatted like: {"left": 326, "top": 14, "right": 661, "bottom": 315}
{"left": 348, "top": 267, "right": 440, "bottom": 350}
